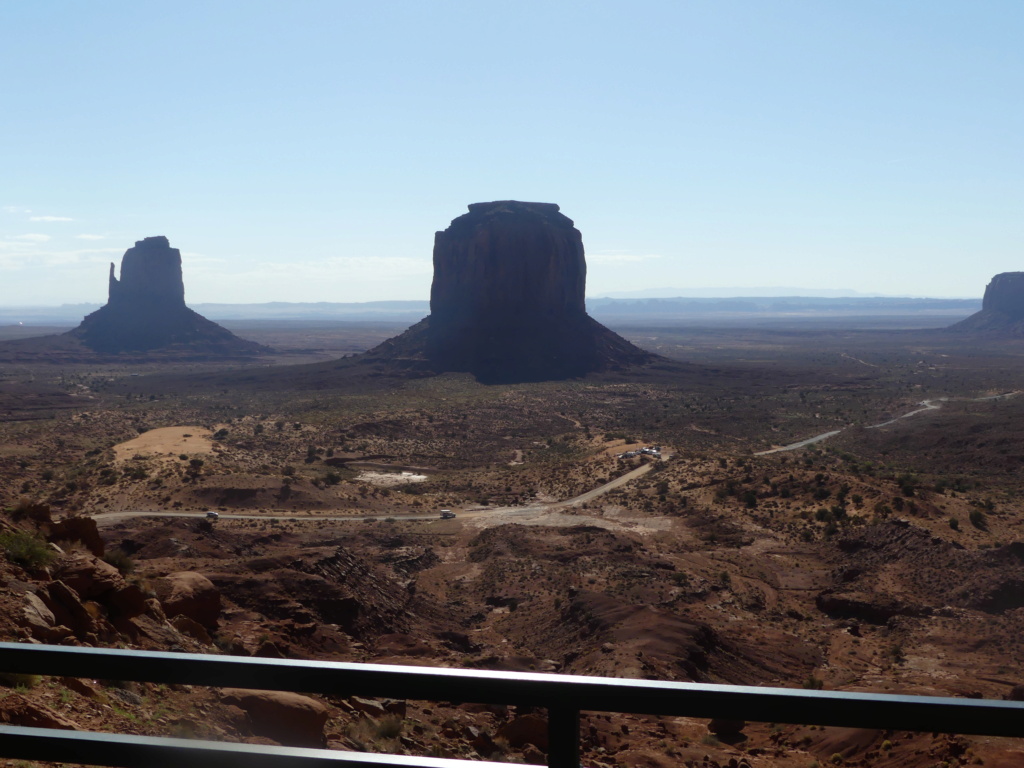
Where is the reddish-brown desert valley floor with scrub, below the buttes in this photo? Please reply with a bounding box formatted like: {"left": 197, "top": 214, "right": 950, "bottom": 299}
{"left": 0, "top": 241, "right": 1024, "bottom": 768}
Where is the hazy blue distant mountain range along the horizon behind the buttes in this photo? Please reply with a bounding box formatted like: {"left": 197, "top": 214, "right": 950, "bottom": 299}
{"left": 0, "top": 292, "right": 981, "bottom": 326}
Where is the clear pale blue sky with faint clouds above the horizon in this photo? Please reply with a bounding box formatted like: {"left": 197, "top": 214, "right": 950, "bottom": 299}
{"left": 0, "top": 0, "right": 1024, "bottom": 306}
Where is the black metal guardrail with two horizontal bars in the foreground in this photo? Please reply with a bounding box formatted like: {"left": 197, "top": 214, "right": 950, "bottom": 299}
{"left": 0, "top": 643, "right": 1024, "bottom": 768}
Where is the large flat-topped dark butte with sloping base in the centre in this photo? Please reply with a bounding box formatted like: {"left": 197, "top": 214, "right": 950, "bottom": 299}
{"left": 370, "top": 200, "right": 655, "bottom": 382}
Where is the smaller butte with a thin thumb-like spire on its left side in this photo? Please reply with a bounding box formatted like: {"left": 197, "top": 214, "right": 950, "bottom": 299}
{"left": 69, "top": 237, "right": 262, "bottom": 354}
